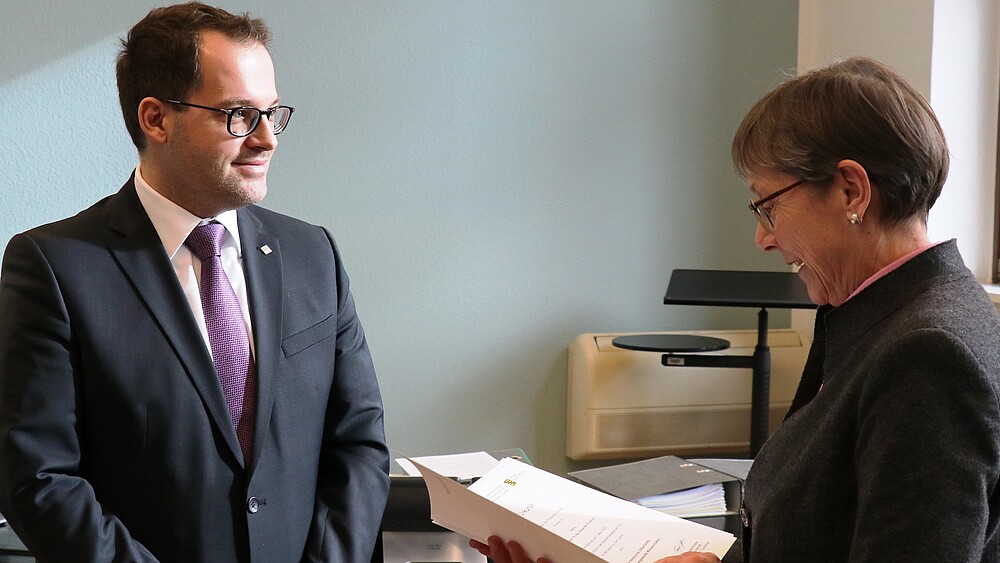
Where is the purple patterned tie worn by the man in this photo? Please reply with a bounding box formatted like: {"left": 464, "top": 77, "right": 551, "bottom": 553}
{"left": 184, "top": 223, "right": 257, "bottom": 464}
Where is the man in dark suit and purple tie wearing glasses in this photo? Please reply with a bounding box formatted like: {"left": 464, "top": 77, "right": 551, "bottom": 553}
{"left": 0, "top": 3, "right": 389, "bottom": 563}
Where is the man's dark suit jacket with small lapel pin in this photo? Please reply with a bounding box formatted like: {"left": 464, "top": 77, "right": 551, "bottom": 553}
{"left": 0, "top": 181, "right": 389, "bottom": 563}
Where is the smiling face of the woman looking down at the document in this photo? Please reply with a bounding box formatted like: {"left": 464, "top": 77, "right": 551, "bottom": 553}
{"left": 747, "top": 172, "right": 865, "bottom": 306}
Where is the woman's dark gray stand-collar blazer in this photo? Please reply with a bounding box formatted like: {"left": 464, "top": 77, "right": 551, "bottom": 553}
{"left": 740, "top": 241, "right": 1000, "bottom": 563}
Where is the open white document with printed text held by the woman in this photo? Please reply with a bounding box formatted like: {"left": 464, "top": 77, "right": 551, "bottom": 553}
{"left": 411, "top": 458, "right": 736, "bottom": 563}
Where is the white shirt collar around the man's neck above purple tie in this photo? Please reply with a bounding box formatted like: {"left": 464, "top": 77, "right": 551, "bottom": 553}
{"left": 135, "top": 166, "right": 243, "bottom": 260}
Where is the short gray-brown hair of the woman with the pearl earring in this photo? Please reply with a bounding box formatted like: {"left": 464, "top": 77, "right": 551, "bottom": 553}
{"left": 733, "top": 57, "right": 949, "bottom": 224}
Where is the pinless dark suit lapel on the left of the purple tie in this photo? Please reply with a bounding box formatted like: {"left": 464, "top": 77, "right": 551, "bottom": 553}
{"left": 108, "top": 179, "right": 242, "bottom": 459}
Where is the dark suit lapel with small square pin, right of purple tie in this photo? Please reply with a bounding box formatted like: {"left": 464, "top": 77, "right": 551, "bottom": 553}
{"left": 237, "top": 207, "right": 284, "bottom": 474}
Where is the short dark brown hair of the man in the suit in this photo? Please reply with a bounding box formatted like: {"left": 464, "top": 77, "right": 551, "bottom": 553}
{"left": 115, "top": 2, "right": 271, "bottom": 152}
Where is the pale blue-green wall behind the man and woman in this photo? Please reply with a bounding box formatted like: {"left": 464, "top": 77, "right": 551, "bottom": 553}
{"left": 0, "top": 0, "right": 798, "bottom": 472}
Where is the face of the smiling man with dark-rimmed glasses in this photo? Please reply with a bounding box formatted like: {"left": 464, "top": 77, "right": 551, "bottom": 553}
{"left": 164, "top": 32, "right": 278, "bottom": 217}
